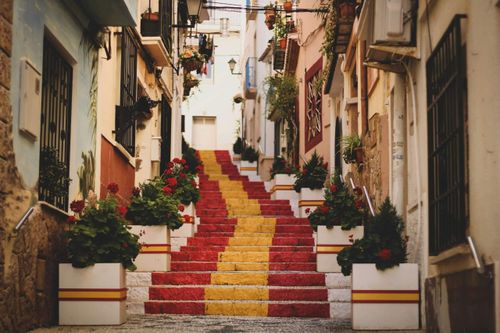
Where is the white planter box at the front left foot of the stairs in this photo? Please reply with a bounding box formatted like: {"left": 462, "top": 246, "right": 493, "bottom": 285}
{"left": 59, "top": 264, "right": 127, "bottom": 325}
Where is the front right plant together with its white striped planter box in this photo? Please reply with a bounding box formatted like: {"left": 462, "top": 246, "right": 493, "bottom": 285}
{"left": 337, "top": 198, "right": 420, "bottom": 330}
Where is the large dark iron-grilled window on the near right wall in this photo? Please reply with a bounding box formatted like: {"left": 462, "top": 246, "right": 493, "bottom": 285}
{"left": 427, "top": 16, "right": 468, "bottom": 255}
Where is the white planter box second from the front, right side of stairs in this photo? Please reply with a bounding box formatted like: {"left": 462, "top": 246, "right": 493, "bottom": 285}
{"left": 316, "top": 225, "right": 364, "bottom": 273}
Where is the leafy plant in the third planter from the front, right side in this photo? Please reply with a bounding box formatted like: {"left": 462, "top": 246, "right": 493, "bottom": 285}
{"left": 294, "top": 151, "right": 328, "bottom": 192}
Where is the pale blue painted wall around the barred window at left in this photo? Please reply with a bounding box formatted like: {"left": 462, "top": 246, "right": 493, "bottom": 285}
{"left": 11, "top": 0, "right": 95, "bottom": 201}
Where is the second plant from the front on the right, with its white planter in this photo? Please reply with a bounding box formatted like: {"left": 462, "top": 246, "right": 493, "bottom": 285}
{"left": 306, "top": 173, "right": 366, "bottom": 273}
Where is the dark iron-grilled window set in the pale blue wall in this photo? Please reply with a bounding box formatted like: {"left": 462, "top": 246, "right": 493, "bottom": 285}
{"left": 38, "top": 40, "right": 73, "bottom": 210}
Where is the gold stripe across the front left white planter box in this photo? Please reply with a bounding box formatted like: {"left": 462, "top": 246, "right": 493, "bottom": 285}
{"left": 59, "top": 288, "right": 127, "bottom": 301}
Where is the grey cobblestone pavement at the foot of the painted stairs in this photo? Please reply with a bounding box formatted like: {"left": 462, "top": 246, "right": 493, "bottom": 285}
{"left": 31, "top": 315, "right": 419, "bottom": 333}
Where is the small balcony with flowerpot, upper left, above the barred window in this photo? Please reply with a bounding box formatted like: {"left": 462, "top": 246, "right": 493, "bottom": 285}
{"left": 141, "top": 0, "right": 172, "bottom": 67}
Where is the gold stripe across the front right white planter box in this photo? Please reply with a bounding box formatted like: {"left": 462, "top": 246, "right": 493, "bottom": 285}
{"left": 352, "top": 290, "right": 420, "bottom": 303}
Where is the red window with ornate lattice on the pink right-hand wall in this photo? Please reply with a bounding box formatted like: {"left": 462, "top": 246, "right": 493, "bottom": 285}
{"left": 305, "top": 58, "right": 323, "bottom": 152}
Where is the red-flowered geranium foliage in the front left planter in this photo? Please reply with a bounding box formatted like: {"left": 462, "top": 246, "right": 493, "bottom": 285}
{"left": 65, "top": 184, "right": 140, "bottom": 271}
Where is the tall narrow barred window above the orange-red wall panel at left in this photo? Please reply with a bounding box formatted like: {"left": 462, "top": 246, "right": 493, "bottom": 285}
{"left": 115, "top": 27, "right": 137, "bottom": 156}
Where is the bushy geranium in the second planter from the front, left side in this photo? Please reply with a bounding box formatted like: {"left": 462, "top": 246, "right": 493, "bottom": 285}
{"left": 126, "top": 177, "right": 182, "bottom": 230}
